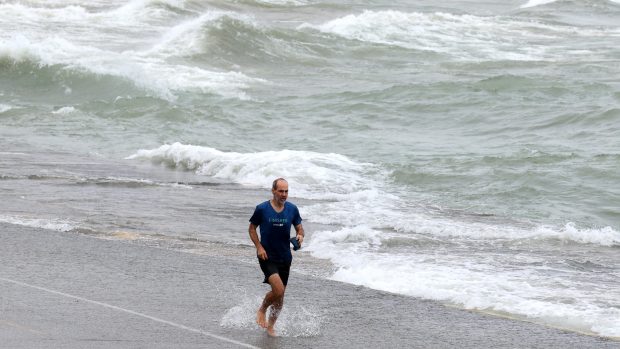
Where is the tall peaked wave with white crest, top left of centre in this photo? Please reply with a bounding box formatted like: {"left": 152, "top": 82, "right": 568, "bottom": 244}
{"left": 143, "top": 10, "right": 330, "bottom": 69}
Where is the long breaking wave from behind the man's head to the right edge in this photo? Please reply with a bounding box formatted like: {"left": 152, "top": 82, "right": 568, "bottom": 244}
{"left": 126, "top": 143, "right": 620, "bottom": 246}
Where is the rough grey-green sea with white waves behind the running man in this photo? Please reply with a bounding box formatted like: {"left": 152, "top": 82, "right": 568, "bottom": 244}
{"left": 0, "top": 0, "right": 620, "bottom": 337}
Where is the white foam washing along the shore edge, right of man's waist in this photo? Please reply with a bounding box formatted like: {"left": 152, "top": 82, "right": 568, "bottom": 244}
{"left": 305, "top": 226, "right": 620, "bottom": 337}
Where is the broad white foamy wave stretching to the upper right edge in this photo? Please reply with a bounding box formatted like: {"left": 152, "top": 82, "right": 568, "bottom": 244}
{"left": 298, "top": 10, "right": 617, "bottom": 61}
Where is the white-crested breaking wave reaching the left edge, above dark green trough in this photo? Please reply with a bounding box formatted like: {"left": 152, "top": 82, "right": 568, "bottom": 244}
{"left": 0, "top": 35, "right": 263, "bottom": 100}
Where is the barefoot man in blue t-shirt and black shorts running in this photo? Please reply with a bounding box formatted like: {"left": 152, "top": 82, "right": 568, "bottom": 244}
{"left": 248, "top": 178, "right": 304, "bottom": 336}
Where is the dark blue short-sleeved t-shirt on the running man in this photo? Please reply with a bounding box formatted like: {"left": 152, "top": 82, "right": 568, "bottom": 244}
{"left": 250, "top": 201, "right": 301, "bottom": 263}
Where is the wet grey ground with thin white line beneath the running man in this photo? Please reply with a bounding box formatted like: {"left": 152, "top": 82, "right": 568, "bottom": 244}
{"left": 0, "top": 224, "right": 620, "bottom": 348}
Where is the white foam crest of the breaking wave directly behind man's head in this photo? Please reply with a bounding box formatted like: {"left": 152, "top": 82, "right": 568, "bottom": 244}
{"left": 127, "top": 143, "right": 378, "bottom": 199}
